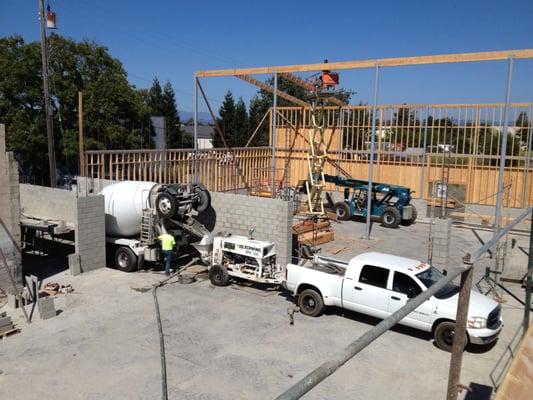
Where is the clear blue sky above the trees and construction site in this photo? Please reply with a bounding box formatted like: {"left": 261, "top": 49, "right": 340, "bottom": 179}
{"left": 0, "top": 0, "right": 533, "bottom": 111}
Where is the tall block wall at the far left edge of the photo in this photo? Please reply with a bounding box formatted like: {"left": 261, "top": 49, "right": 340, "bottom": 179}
{"left": 0, "top": 124, "right": 22, "bottom": 291}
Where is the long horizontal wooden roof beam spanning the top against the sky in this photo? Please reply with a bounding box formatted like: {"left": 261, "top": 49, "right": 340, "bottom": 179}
{"left": 195, "top": 49, "right": 533, "bottom": 78}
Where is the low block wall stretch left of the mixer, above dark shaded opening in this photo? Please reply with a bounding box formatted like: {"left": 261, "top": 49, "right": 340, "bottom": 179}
{"left": 20, "top": 184, "right": 77, "bottom": 225}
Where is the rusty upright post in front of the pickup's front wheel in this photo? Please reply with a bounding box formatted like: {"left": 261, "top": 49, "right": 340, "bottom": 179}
{"left": 446, "top": 265, "right": 474, "bottom": 400}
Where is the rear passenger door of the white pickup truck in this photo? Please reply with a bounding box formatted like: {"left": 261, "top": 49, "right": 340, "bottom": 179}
{"left": 342, "top": 265, "right": 390, "bottom": 318}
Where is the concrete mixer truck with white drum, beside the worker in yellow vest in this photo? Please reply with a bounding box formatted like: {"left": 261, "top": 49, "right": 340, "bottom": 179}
{"left": 100, "top": 181, "right": 213, "bottom": 272}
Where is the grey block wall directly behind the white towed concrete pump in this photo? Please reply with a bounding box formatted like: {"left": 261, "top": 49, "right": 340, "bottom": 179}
{"left": 211, "top": 192, "right": 293, "bottom": 265}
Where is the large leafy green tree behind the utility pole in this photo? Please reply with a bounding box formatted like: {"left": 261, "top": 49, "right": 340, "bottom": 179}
{"left": 0, "top": 34, "right": 151, "bottom": 183}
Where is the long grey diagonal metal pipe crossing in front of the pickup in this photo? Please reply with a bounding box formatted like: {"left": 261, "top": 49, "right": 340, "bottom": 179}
{"left": 276, "top": 207, "right": 533, "bottom": 400}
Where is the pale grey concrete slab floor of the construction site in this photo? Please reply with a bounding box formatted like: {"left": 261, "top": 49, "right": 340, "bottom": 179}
{"left": 0, "top": 222, "right": 528, "bottom": 400}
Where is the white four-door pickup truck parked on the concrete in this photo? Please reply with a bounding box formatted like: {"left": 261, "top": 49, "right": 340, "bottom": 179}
{"left": 284, "top": 253, "right": 503, "bottom": 351}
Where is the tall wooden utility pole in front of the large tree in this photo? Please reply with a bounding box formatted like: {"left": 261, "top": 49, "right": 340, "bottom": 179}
{"left": 38, "top": 0, "right": 57, "bottom": 188}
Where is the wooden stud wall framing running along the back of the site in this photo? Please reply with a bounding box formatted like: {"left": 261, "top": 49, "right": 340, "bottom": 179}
{"left": 85, "top": 103, "right": 533, "bottom": 208}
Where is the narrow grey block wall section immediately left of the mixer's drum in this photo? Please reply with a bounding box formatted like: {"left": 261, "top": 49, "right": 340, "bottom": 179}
{"left": 69, "top": 196, "right": 106, "bottom": 275}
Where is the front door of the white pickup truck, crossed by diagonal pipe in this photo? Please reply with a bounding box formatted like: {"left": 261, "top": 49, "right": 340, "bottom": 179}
{"left": 389, "top": 271, "right": 434, "bottom": 331}
